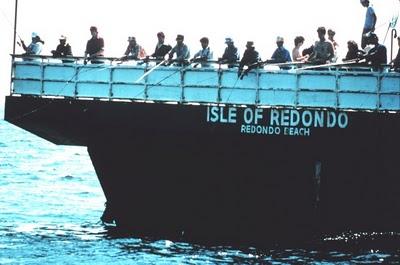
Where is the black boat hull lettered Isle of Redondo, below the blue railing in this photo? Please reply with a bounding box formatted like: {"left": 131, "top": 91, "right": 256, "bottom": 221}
{"left": 5, "top": 97, "right": 400, "bottom": 245}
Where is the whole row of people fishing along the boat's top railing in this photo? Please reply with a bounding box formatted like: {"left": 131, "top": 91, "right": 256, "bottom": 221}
{"left": 21, "top": 0, "right": 400, "bottom": 75}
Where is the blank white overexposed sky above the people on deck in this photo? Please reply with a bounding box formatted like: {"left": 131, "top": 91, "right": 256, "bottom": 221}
{"left": 0, "top": 0, "right": 400, "bottom": 101}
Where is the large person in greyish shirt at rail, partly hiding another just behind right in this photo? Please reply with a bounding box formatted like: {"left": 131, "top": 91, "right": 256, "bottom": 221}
{"left": 307, "top": 27, "right": 335, "bottom": 64}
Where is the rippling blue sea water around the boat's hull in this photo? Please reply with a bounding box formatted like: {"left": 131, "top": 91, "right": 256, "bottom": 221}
{"left": 0, "top": 105, "right": 400, "bottom": 264}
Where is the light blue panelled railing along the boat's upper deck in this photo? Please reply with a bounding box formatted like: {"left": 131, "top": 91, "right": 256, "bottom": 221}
{"left": 11, "top": 56, "right": 400, "bottom": 111}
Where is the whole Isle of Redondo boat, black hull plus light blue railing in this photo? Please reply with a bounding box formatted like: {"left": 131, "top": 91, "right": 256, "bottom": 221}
{"left": 5, "top": 55, "right": 400, "bottom": 245}
